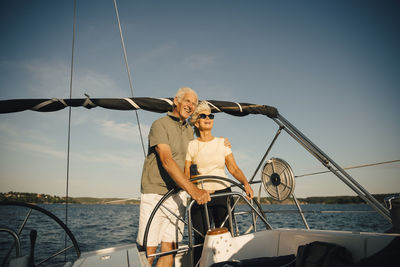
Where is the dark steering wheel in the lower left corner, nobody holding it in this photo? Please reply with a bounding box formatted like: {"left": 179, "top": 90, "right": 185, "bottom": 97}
{"left": 0, "top": 201, "right": 81, "bottom": 267}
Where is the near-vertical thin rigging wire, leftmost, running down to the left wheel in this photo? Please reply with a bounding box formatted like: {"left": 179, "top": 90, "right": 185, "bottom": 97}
{"left": 64, "top": 0, "right": 76, "bottom": 258}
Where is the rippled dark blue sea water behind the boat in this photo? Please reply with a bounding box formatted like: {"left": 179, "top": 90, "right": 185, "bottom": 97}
{"left": 0, "top": 204, "right": 391, "bottom": 266}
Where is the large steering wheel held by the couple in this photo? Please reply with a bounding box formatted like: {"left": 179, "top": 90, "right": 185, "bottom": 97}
{"left": 143, "top": 175, "right": 271, "bottom": 266}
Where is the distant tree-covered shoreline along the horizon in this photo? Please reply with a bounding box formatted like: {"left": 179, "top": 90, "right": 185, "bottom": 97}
{"left": 0, "top": 192, "right": 396, "bottom": 205}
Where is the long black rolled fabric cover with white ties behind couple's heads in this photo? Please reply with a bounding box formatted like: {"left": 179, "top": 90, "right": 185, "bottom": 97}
{"left": 0, "top": 97, "right": 278, "bottom": 118}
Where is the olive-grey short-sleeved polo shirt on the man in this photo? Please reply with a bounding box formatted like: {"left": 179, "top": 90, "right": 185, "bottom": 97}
{"left": 141, "top": 112, "right": 193, "bottom": 195}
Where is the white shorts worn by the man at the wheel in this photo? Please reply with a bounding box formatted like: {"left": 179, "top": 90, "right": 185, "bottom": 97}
{"left": 136, "top": 191, "right": 187, "bottom": 247}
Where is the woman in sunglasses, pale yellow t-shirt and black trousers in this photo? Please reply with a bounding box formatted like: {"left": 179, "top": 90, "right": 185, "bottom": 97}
{"left": 185, "top": 101, "right": 253, "bottom": 262}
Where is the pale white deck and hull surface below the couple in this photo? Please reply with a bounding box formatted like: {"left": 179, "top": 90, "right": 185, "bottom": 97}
{"left": 73, "top": 229, "right": 400, "bottom": 267}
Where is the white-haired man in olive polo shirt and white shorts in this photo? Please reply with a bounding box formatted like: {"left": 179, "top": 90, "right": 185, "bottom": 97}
{"left": 137, "top": 87, "right": 211, "bottom": 266}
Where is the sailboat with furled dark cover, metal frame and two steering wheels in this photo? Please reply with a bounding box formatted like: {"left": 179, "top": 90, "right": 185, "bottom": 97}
{"left": 0, "top": 96, "right": 400, "bottom": 267}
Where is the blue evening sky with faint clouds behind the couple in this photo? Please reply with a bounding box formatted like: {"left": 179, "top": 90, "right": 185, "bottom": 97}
{"left": 0, "top": 0, "right": 400, "bottom": 198}
